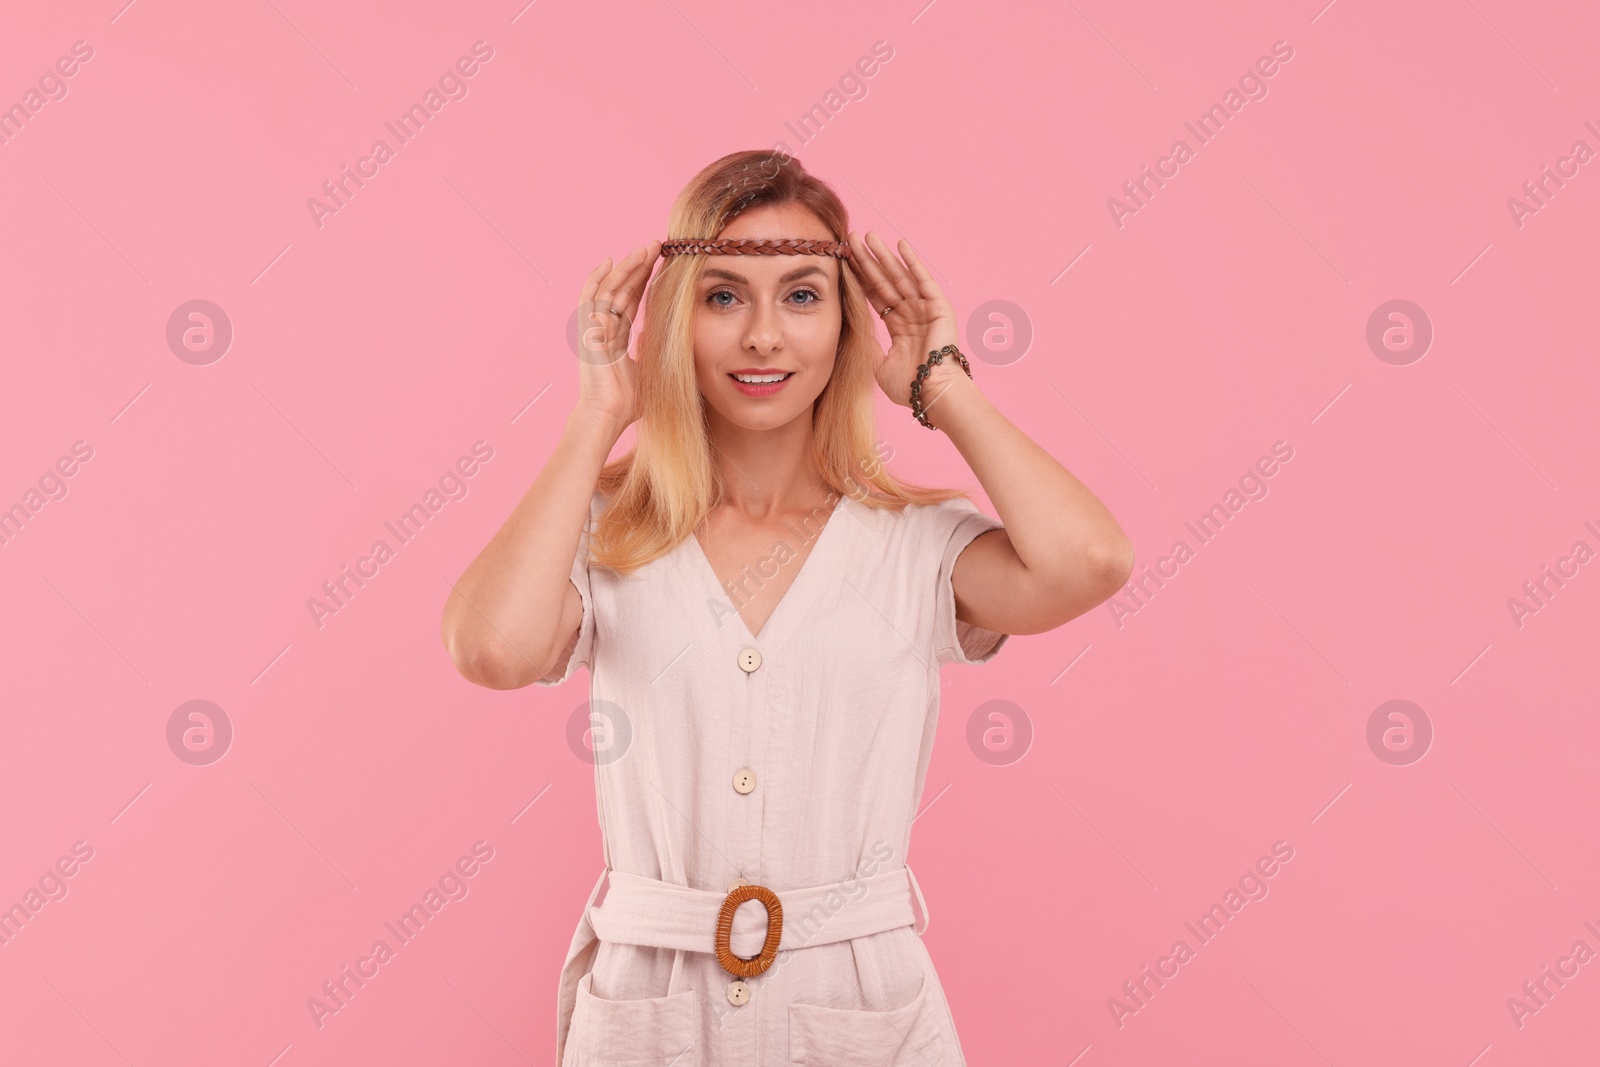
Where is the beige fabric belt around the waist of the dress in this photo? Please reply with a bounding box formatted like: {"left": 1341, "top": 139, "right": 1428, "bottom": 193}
{"left": 589, "top": 865, "right": 928, "bottom": 957}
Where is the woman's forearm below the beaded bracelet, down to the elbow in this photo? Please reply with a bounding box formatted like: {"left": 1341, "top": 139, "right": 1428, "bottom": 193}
{"left": 922, "top": 362, "right": 1133, "bottom": 585}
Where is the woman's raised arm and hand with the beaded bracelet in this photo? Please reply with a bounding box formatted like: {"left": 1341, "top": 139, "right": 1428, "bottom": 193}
{"left": 850, "top": 232, "right": 1133, "bottom": 633}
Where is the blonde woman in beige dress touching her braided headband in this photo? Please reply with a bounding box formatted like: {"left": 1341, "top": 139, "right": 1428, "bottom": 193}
{"left": 443, "top": 152, "right": 1133, "bottom": 1067}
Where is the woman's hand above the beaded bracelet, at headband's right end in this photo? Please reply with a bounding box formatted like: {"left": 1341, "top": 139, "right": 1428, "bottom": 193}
{"left": 848, "top": 230, "right": 960, "bottom": 408}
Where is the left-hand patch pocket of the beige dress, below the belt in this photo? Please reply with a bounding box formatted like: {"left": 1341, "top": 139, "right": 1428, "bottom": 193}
{"left": 562, "top": 971, "right": 702, "bottom": 1067}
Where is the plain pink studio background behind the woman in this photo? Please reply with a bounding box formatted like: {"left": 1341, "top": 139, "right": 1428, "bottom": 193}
{"left": 0, "top": 0, "right": 1600, "bottom": 1067}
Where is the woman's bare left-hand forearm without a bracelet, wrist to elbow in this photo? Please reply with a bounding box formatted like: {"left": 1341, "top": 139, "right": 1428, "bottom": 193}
{"left": 442, "top": 411, "right": 621, "bottom": 688}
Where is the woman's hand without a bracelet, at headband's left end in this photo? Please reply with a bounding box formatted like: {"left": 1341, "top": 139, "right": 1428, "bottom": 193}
{"left": 578, "top": 242, "right": 661, "bottom": 434}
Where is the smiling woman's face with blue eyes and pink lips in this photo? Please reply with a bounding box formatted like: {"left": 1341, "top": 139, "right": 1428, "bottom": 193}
{"left": 694, "top": 203, "right": 843, "bottom": 430}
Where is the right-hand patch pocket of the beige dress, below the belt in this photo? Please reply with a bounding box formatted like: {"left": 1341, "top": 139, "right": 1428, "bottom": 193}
{"left": 789, "top": 976, "right": 944, "bottom": 1067}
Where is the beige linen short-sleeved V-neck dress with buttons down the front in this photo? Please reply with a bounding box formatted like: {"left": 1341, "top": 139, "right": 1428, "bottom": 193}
{"left": 538, "top": 493, "right": 1006, "bottom": 1067}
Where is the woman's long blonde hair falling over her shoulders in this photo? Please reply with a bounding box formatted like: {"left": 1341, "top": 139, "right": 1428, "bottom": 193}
{"left": 590, "top": 150, "right": 962, "bottom": 573}
